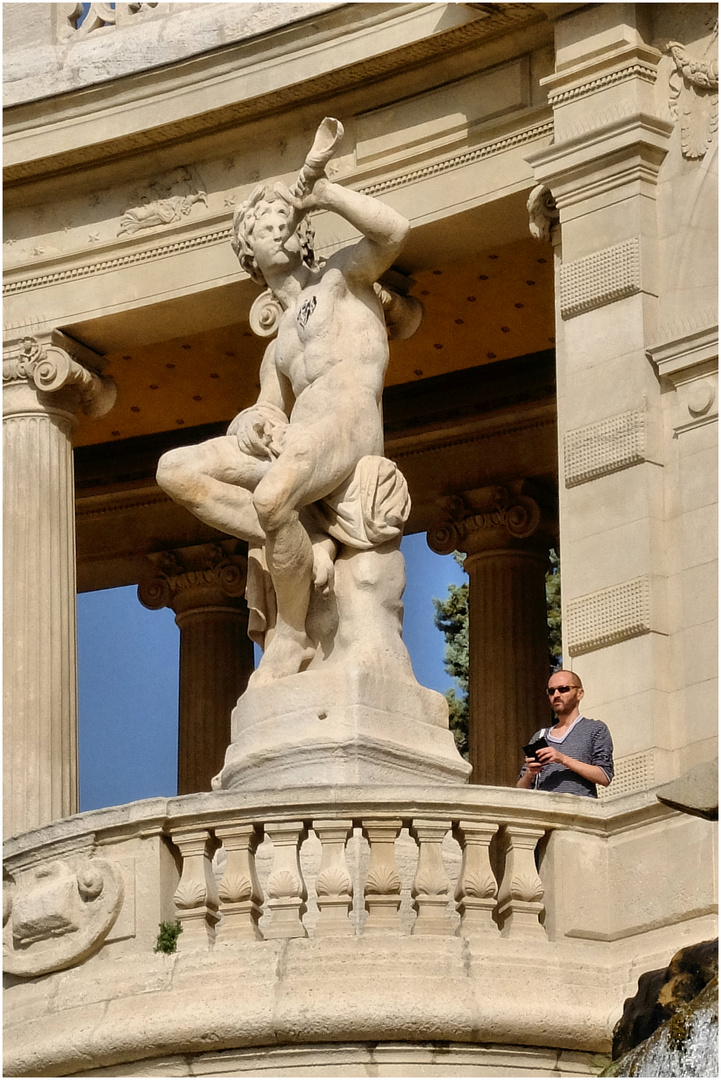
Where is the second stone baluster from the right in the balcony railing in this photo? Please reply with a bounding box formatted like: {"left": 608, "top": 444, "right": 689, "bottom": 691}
{"left": 455, "top": 821, "right": 499, "bottom": 937}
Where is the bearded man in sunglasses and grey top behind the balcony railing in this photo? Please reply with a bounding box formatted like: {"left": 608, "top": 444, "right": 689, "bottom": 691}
{"left": 516, "top": 671, "right": 613, "bottom": 798}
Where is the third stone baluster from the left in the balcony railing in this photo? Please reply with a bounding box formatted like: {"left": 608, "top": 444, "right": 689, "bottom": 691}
{"left": 263, "top": 821, "right": 308, "bottom": 940}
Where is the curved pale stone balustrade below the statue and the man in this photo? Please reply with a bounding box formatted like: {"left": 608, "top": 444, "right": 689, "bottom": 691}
{"left": 5, "top": 786, "right": 708, "bottom": 977}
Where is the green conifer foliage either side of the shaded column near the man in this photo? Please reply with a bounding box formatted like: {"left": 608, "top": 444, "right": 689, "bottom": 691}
{"left": 433, "top": 548, "right": 561, "bottom": 759}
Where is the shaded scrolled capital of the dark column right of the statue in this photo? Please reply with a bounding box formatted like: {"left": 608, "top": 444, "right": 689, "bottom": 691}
{"left": 428, "top": 482, "right": 546, "bottom": 555}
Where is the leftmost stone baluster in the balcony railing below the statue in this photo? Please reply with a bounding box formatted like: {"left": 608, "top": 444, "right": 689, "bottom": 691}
{"left": 171, "top": 829, "right": 220, "bottom": 949}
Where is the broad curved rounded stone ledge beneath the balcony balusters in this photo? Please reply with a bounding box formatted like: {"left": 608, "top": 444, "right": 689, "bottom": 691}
{"left": 4, "top": 935, "right": 623, "bottom": 1076}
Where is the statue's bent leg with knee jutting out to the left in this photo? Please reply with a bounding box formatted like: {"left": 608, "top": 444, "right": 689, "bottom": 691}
{"left": 158, "top": 435, "right": 271, "bottom": 543}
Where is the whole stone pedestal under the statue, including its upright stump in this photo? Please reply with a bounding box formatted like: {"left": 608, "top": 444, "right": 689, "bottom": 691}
{"left": 214, "top": 541, "right": 471, "bottom": 789}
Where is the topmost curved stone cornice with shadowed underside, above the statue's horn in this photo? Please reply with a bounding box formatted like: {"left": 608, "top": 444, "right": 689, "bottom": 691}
{"left": 4, "top": 3, "right": 543, "bottom": 189}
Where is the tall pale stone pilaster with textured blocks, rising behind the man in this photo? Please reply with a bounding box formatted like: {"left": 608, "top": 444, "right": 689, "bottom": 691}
{"left": 528, "top": 3, "right": 674, "bottom": 789}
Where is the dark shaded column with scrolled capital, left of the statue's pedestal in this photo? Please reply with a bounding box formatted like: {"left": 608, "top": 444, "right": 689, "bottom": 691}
{"left": 138, "top": 540, "right": 253, "bottom": 795}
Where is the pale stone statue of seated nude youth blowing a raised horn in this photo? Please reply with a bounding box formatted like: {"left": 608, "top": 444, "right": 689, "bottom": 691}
{"left": 158, "top": 118, "right": 468, "bottom": 786}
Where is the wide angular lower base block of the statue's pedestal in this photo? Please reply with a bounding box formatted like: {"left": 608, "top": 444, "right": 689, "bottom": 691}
{"left": 214, "top": 665, "right": 471, "bottom": 791}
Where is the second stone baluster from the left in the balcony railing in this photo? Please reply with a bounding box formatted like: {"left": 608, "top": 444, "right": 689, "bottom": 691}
{"left": 215, "top": 825, "right": 263, "bottom": 941}
